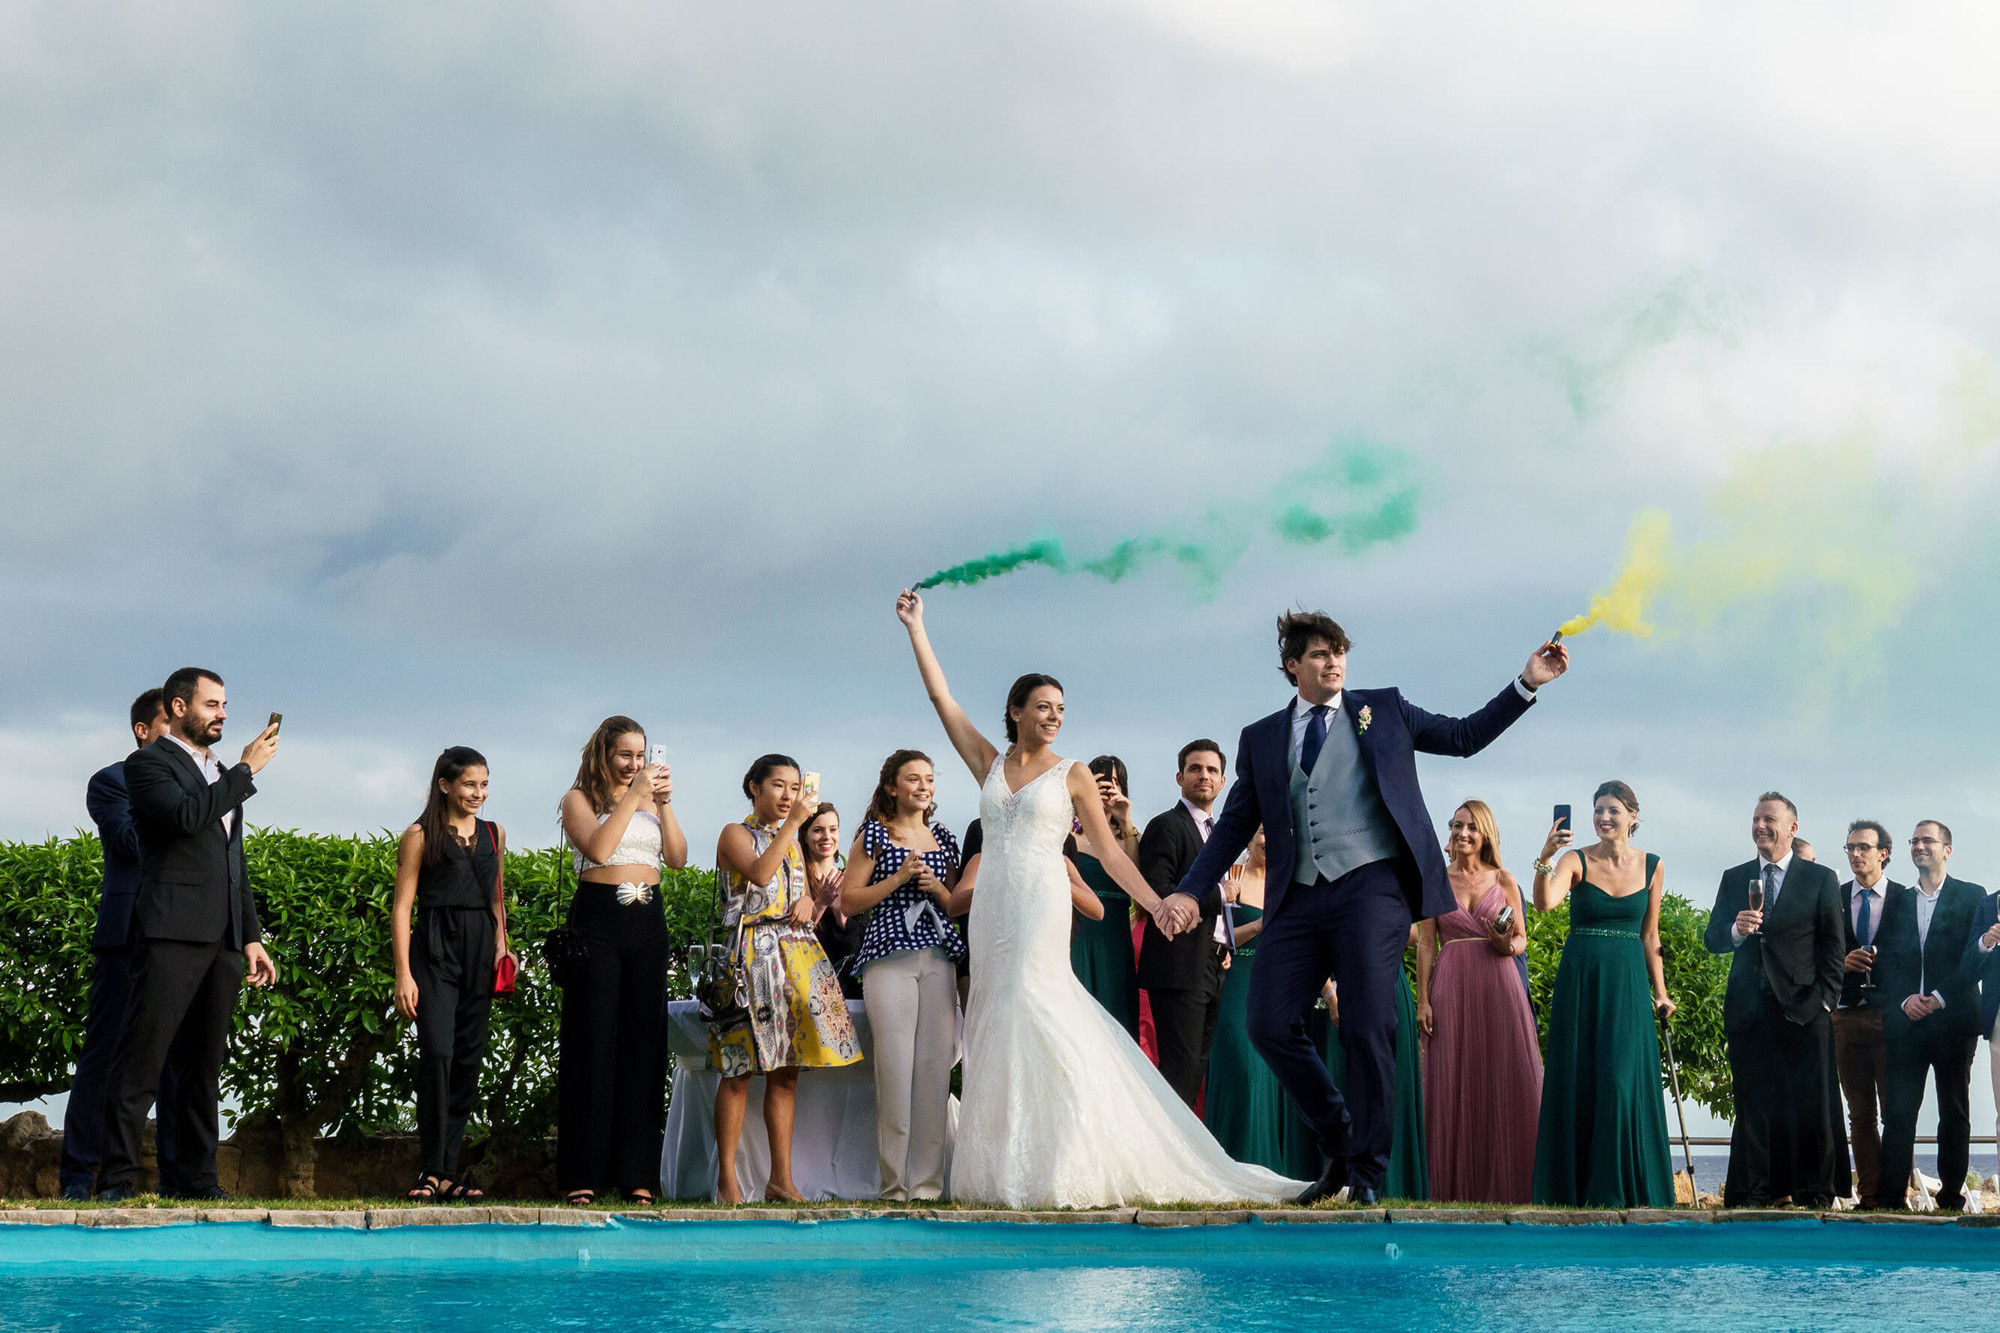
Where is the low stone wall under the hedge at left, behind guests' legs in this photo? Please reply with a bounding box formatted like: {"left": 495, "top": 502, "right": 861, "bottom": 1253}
{"left": 0, "top": 1111, "right": 556, "bottom": 1199}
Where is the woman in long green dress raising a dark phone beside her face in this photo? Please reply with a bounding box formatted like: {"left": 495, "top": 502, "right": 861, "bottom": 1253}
{"left": 1534, "top": 783, "right": 1674, "bottom": 1209}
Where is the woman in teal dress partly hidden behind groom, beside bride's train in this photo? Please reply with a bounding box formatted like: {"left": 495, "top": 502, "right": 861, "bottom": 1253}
{"left": 1202, "top": 829, "right": 1320, "bottom": 1181}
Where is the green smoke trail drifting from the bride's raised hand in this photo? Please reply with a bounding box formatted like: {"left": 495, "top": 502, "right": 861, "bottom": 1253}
{"left": 916, "top": 440, "right": 1420, "bottom": 596}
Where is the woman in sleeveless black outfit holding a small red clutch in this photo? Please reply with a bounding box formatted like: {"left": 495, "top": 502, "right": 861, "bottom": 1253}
{"left": 390, "top": 745, "right": 508, "bottom": 1203}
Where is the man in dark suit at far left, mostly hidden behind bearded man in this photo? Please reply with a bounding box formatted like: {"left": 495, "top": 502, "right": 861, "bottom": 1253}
{"left": 60, "top": 689, "right": 199, "bottom": 1201}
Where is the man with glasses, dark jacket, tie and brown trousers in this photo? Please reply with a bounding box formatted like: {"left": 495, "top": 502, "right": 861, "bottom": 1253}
{"left": 1832, "top": 819, "right": 1902, "bottom": 1211}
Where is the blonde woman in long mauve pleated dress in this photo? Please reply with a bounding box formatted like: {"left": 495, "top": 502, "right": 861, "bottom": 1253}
{"left": 1416, "top": 801, "right": 1542, "bottom": 1203}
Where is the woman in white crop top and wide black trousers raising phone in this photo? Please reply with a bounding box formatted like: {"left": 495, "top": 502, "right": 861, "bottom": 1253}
{"left": 556, "top": 717, "right": 688, "bottom": 1205}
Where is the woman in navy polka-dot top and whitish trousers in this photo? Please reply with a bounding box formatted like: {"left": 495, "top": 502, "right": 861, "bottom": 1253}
{"left": 840, "top": 751, "right": 966, "bottom": 1199}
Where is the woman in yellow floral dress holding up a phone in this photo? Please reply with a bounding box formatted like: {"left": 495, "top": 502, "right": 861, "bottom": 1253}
{"left": 708, "top": 755, "right": 862, "bottom": 1203}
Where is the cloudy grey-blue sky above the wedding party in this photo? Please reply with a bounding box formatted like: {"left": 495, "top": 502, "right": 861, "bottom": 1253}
{"left": 0, "top": 0, "right": 2000, "bottom": 1128}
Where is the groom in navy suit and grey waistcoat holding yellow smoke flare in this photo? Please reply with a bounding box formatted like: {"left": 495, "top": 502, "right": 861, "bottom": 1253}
{"left": 1168, "top": 612, "right": 1570, "bottom": 1203}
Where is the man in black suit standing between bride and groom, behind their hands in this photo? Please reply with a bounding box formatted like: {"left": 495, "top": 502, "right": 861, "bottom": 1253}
{"left": 1138, "top": 741, "right": 1228, "bottom": 1109}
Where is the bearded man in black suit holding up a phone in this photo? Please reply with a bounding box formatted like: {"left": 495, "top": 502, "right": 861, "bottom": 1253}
{"left": 98, "top": 667, "right": 278, "bottom": 1201}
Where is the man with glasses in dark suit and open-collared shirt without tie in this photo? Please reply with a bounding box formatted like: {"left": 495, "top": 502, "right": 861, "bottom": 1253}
{"left": 1876, "top": 819, "right": 1986, "bottom": 1211}
